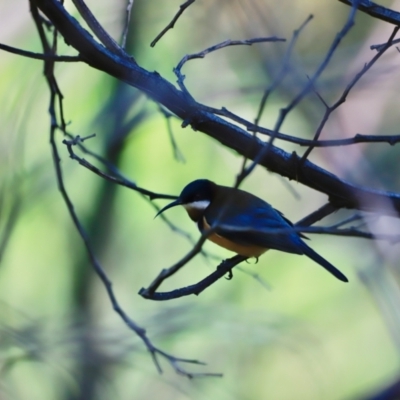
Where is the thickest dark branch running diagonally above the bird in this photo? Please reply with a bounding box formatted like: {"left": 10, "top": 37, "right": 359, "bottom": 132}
{"left": 32, "top": 0, "right": 400, "bottom": 216}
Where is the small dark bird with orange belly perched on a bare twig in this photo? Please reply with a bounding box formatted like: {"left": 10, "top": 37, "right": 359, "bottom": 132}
{"left": 156, "top": 179, "right": 348, "bottom": 282}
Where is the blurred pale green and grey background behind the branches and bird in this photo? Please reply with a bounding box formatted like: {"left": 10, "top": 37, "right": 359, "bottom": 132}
{"left": 0, "top": 0, "right": 400, "bottom": 400}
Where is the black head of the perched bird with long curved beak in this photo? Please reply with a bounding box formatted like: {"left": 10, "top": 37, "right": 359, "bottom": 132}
{"left": 156, "top": 179, "right": 217, "bottom": 221}
